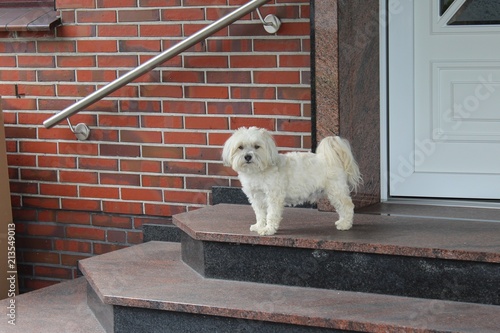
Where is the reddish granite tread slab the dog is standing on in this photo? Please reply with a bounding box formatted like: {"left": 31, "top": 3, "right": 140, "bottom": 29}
{"left": 173, "top": 204, "right": 500, "bottom": 263}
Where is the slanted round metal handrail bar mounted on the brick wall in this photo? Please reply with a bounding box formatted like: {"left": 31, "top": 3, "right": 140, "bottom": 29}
{"left": 43, "top": 0, "right": 270, "bottom": 128}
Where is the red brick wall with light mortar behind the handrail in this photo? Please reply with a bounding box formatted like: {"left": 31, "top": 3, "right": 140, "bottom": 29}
{"left": 0, "top": 0, "right": 311, "bottom": 290}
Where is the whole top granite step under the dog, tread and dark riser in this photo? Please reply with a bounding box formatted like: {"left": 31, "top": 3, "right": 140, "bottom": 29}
{"left": 173, "top": 204, "right": 500, "bottom": 305}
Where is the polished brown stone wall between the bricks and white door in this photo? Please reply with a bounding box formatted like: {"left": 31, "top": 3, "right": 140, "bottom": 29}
{"left": 311, "top": 0, "right": 380, "bottom": 210}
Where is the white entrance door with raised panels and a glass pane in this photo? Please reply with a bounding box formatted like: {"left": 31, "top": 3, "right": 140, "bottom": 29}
{"left": 388, "top": 0, "right": 500, "bottom": 199}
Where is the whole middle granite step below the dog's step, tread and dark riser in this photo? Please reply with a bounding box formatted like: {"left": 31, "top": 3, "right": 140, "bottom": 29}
{"left": 80, "top": 241, "right": 500, "bottom": 333}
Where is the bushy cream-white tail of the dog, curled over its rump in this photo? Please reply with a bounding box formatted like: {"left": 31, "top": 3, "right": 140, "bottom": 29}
{"left": 316, "top": 136, "right": 362, "bottom": 191}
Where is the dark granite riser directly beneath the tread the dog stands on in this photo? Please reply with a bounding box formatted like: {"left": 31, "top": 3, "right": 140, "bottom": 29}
{"left": 181, "top": 233, "right": 500, "bottom": 305}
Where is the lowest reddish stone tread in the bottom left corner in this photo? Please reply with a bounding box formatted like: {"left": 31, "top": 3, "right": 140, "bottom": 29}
{"left": 0, "top": 278, "right": 105, "bottom": 333}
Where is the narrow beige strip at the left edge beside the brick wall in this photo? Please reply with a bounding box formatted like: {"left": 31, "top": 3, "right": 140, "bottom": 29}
{"left": 0, "top": 99, "right": 17, "bottom": 299}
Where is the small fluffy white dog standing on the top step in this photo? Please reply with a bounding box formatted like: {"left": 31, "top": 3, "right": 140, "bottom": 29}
{"left": 222, "top": 127, "right": 361, "bottom": 235}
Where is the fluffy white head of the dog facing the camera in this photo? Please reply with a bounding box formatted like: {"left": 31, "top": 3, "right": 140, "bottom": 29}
{"left": 222, "top": 127, "right": 279, "bottom": 173}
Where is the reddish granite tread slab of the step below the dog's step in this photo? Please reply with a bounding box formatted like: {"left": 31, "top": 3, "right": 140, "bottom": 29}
{"left": 80, "top": 242, "right": 500, "bottom": 333}
